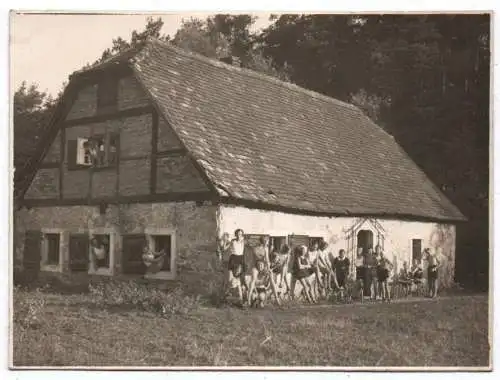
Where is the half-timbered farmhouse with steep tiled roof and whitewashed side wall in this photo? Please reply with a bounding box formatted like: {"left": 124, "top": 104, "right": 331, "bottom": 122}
{"left": 15, "top": 40, "right": 464, "bottom": 285}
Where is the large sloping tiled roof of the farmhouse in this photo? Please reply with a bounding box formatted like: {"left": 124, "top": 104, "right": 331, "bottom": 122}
{"left": 127, "top": 40, "right": 464, "bottom": 220}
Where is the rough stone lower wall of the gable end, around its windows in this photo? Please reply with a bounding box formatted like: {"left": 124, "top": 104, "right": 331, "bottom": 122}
{"left": 14, "top": 202, "right": 216, "bottom": 283}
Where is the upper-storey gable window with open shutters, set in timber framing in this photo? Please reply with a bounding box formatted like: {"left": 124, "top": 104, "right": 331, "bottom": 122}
{"left": 68, "top": 133, "right": 120, "bottom": 169}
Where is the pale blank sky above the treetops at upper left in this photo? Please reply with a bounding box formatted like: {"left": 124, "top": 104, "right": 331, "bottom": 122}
{"left": 10, "top": 13, "right": 270, "bottom": 95}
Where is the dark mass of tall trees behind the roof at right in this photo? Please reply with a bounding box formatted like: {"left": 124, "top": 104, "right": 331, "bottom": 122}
{"left": 261, "top": 15, "right": 490, "bottom": 288}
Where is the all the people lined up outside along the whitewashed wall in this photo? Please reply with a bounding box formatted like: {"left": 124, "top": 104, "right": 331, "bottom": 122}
{"left": 218, "top": 229, "right": 439, "bottom": 307}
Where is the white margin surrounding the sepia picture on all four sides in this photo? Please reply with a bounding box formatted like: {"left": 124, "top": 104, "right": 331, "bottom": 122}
{"left": 0, "top": 0, "right": 500, "bottom": 380}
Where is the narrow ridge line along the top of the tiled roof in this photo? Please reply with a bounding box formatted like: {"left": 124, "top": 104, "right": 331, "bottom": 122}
{"left": 148, "top": 38, "right": 362, "bottom": 112}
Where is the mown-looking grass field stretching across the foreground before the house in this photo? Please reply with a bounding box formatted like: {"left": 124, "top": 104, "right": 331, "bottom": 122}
{"left": 13, "top": 280, "right": 490, "bottom": 367}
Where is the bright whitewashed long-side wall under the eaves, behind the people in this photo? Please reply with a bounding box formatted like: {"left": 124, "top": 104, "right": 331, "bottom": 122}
{"left": 217, "top": 205, "right": 455, "bottom": 286}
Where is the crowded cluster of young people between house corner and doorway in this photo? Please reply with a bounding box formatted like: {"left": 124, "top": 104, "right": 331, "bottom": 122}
{"left": 218, "top": 229, "right": 350, "bottom": 307}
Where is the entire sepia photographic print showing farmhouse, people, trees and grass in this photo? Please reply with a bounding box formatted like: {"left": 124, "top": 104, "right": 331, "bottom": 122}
{"left": 9, "top": 12, "right": 492, "bottom": 371}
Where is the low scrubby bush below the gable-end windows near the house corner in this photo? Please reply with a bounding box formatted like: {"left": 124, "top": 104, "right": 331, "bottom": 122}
{"left": 89, "top": 281, "right": 200, "bottom": 316}
